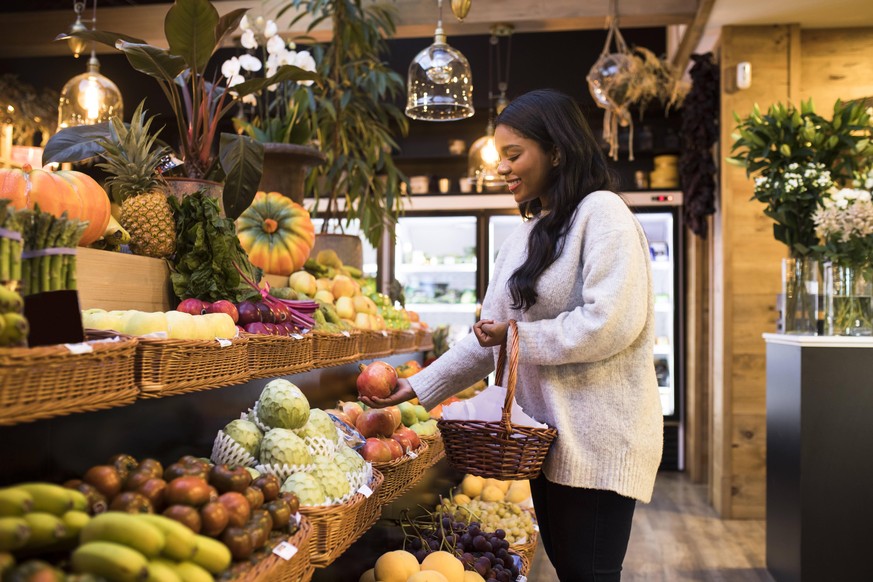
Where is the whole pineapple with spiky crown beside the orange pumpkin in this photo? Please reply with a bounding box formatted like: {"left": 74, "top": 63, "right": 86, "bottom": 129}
{"left": 98, "top": 103, "right": 176, "bottom": 258}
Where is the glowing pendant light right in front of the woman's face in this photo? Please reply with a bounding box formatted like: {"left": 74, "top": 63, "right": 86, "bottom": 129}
{"left": 467, "top": 24, "right": 513, "bottom": 193}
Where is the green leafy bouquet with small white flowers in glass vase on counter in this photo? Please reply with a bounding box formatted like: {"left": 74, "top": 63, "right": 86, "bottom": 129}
{"left": 728, "top": 100, "right": 873, "bottom": 335}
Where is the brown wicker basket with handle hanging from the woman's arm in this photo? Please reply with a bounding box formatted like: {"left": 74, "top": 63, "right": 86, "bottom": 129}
{"left": 437, "top": 320, "right": 558, "bottom": 481}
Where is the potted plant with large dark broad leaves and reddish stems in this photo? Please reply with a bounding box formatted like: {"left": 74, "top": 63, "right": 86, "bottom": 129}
{"left": 46, "top": 0, "right": 315, "bottom": 218}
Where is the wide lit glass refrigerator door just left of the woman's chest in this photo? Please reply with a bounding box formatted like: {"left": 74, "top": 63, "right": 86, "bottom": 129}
{"left": 394, "top": 216, "right": 478, "bottom": 331}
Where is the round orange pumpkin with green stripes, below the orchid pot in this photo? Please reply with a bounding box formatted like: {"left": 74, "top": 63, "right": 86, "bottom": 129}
{"left": 236, "top": 192, "right": 315, "bottom": 275}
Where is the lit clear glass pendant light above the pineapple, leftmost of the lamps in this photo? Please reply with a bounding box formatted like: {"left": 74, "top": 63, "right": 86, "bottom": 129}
{"left": 58, "top": 0, "right": 124, "bottom": 130}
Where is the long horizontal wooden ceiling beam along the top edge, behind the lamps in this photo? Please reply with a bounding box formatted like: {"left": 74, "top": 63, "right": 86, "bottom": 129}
{"left": 0, "top": 0, "right": 696, "bottom": 58}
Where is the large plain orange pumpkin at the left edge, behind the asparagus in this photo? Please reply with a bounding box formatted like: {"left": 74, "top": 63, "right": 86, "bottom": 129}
{"left": 0, "top": 165, "right": 110, "bottom": 246}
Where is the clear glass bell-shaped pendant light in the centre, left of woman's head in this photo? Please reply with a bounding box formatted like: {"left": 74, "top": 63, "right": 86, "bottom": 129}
{"left": 406, "top": 0, "right": 475, "bottom": 121}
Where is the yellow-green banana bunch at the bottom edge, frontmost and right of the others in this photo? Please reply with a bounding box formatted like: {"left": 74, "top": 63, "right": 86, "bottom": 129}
{"left": 70, "top": 511, "right": 231, "bottom": 582}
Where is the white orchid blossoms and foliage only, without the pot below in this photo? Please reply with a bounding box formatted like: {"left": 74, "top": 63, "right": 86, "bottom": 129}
{"left": 221, "top": 16, "right": 316, "bottom": 145}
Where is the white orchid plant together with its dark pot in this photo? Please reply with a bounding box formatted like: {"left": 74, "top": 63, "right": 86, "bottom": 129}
{"left": 221, "top": 16, "right": 324, "bottom": 204}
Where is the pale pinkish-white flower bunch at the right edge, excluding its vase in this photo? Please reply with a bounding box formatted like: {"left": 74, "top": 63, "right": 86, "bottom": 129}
{"left": 813, "top": 170, "right": 873, "bottom": 267}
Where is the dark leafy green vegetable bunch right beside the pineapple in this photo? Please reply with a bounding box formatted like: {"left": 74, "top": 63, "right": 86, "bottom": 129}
{"left": 169, "top": 191, "right": 263, "bottom": 302}
